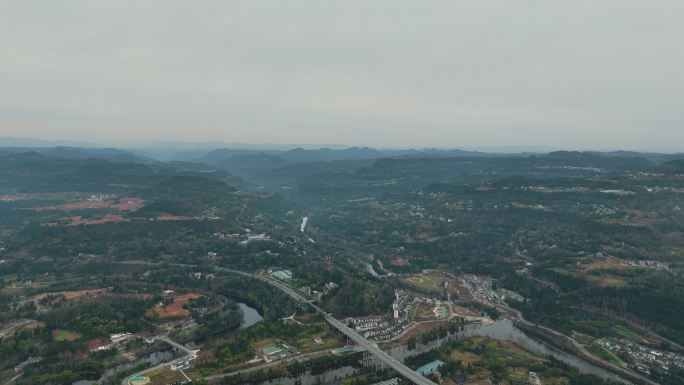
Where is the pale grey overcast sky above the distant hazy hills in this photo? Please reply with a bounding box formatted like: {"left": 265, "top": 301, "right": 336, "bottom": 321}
{"left": 0, "top": 0, "right": 684, "bottom": 149}
